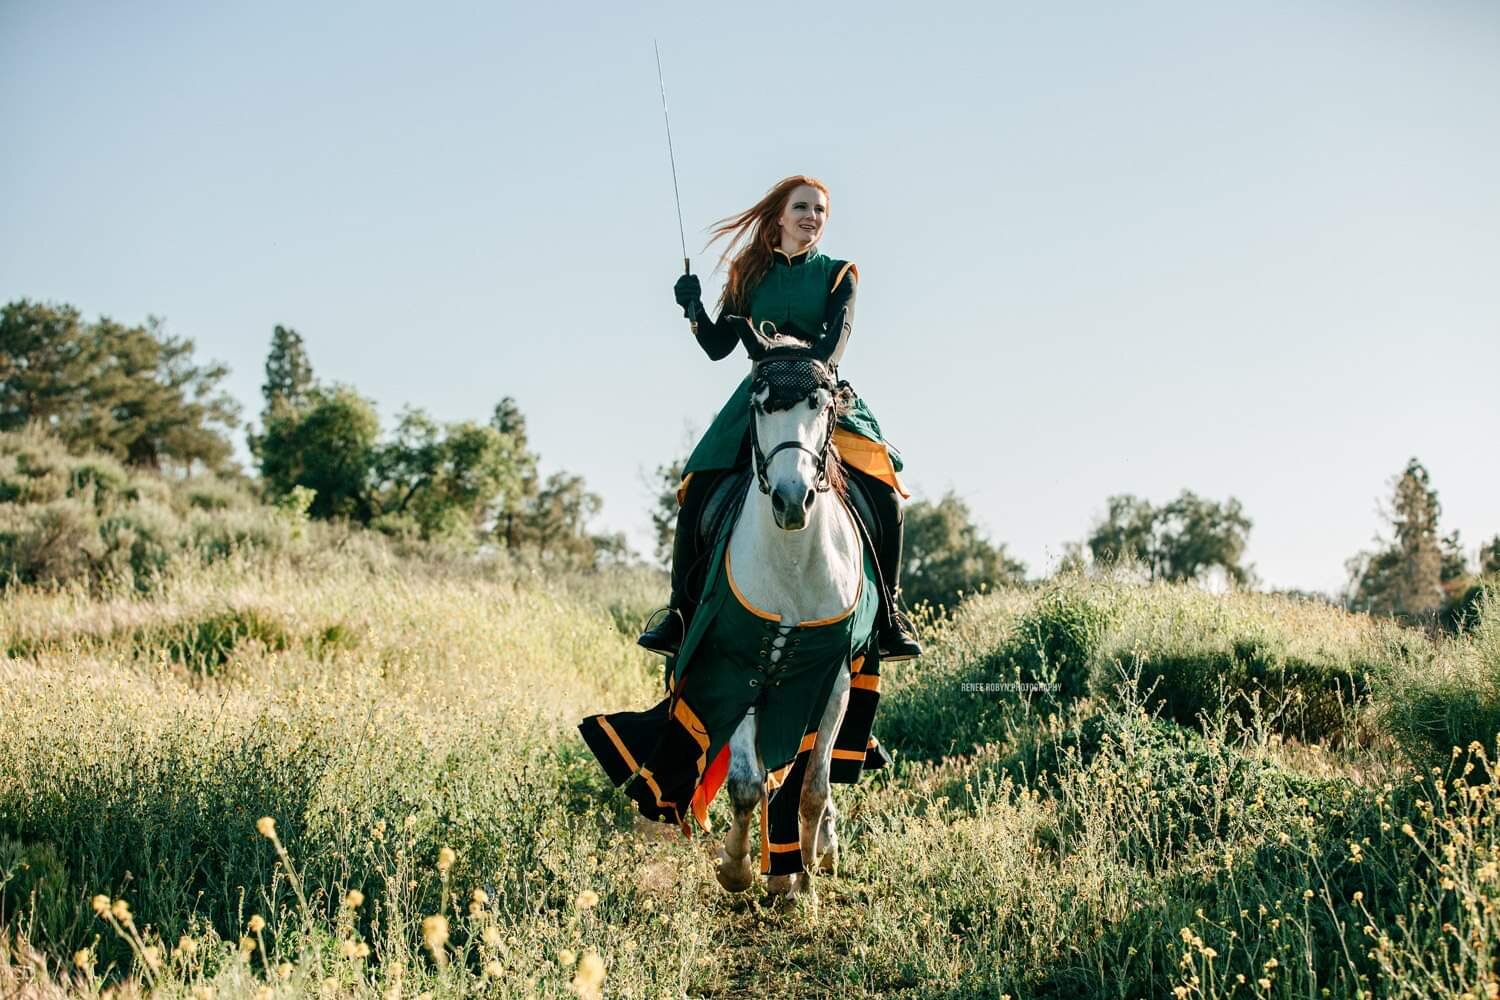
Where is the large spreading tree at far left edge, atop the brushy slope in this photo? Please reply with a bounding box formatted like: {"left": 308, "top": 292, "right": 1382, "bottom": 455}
{"left": 0, "top": 300, "right": 239, "bottom": 469}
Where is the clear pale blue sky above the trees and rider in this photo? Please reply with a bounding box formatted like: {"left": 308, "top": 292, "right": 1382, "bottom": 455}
{"left": 0, "top": 0, "right": 1500, "bottom": 589}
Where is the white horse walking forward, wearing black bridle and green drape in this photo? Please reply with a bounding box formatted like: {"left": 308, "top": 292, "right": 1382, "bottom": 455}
{"left": 717, "top": 337, "right": 864, "bottom": 898}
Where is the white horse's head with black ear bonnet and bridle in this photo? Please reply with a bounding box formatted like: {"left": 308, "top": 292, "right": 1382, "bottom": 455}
{"left": 741, "top": 322, "right": 846, "bottom": 531}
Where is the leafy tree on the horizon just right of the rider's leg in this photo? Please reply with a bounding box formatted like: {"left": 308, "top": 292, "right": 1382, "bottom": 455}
{"left": 902, "top": 492, "right": 1026, "bottom": 607}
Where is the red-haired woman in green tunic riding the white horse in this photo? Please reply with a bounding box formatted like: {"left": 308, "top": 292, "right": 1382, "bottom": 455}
{"left": 638, "top": 175, "right": 921, "bottom": 660}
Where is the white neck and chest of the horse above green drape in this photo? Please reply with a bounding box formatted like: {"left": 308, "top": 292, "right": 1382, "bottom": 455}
{"left": 729, "top": 481, "right": 863, "bottom": 625}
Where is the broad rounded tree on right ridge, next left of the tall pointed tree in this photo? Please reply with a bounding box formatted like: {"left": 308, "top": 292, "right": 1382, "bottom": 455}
{"left": 1088, "top": 490, "right": 1253, "bottom": 586}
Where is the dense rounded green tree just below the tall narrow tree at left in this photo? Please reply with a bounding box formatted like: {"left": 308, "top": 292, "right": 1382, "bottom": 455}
{"left": 260, "top": 387, "right": 380, "bottom": 523}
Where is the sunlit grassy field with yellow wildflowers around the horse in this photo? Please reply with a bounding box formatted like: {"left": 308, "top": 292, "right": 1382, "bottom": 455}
{"left": 0, "top": 515, "right": 1500, "bottom": 1000}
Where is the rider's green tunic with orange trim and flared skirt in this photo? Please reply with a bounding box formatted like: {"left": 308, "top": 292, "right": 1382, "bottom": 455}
{"left": 683, "top": 246, "right": 902, "bottom": 475}
